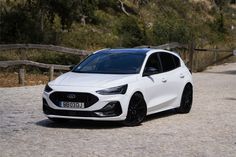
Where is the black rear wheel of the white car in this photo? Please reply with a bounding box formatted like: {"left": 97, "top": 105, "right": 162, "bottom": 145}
{"left": 176, "top": 84, "right": 193, "bottom": 113}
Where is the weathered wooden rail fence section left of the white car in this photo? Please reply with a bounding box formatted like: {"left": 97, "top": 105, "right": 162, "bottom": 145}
{"left": 0, "top": 44, "right": 90, "bottom": 85}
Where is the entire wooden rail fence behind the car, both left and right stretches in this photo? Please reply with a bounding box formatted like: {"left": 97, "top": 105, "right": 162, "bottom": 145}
{"left": 0, "top": 42, "right": 233, "bottom": 85}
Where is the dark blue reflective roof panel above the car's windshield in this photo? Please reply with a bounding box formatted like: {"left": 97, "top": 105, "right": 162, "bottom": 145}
{"left": 96, "top": 48, "right": 151, "bottom": 54}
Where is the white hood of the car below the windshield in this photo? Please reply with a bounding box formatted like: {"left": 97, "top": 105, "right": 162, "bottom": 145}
{"left": 50, "top": 72, "right": 138, "bottom": 87}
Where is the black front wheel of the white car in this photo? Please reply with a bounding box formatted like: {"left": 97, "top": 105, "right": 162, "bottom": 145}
{"left": 123, "top": 93, "right": 147, "bottom": 126}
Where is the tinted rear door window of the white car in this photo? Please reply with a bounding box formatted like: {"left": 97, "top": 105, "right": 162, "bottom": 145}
{"left": 159, "top": 52, "right": 175, "bottom": 72}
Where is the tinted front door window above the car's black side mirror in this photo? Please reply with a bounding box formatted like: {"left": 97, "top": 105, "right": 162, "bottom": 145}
{"left": 145, "top": 53, "right": 161, "bottom": 73}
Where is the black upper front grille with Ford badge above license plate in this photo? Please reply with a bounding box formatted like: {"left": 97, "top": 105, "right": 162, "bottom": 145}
{"left": 49, "top": 92, "right": 99, "bottom": 108}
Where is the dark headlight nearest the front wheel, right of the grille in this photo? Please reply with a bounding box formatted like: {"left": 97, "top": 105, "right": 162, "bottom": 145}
{"left": 96, "top": 84, "right": 128, "bottom": 95}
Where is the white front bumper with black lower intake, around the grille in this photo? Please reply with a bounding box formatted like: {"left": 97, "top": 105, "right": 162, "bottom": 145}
{"left": 43, "top": 89, "right": 129, "bottom": 121}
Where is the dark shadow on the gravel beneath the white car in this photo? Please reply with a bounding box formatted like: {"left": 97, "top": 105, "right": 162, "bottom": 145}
{"left": 35, "top": 110, "right": 176, "bottom": 129}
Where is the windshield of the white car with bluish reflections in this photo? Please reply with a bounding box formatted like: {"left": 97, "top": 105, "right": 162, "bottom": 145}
{"left": 73, "top": 52, "right": 145, "bottom": 74}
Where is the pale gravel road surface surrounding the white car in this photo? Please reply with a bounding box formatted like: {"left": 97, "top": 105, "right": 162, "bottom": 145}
{"left": 0, "top": 63, "right": 236, "bottom": 157}
